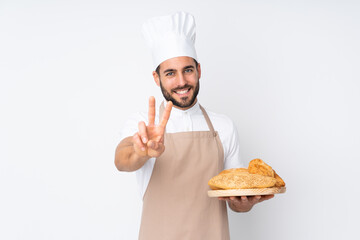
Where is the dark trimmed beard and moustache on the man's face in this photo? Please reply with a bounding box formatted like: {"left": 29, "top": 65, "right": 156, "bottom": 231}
{"left": 160, "top": 79, "right": 200, "bottom": 108}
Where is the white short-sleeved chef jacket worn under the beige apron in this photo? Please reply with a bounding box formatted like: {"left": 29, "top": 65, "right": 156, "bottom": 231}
{"left": 120, "top": 101, "right": 245, "bottom": 197}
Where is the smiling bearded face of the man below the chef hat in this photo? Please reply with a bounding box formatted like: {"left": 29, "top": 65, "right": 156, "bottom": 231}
{"left": 153, "top": 57, "right": 201, "bottom": 110}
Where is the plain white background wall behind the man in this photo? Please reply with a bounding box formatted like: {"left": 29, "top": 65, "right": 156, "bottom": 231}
{"left": 0, "top": 0, "right": 360, "bottom": 240}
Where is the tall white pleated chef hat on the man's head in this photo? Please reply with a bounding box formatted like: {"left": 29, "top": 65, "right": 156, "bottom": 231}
{"left": 142, "top": 12, "right": 197, "bottom": 69}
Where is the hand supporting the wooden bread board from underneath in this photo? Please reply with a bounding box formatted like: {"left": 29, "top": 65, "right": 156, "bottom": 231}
{"left": 219, "top": 195, "right": 274, "bottom": 212}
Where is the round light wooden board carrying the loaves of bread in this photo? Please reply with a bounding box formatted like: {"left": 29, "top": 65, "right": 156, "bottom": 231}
{"left": 208, "top": 187, "right": 286, "bottom": 197}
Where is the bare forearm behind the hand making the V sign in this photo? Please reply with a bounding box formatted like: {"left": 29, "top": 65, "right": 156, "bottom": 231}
{"left": 115, "top": 137, "right": 150, "bottom": 172}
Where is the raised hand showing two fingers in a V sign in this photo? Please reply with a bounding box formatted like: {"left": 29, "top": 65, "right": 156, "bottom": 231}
{"left": 133, "top": 97, "right": 173, "bottom": 157}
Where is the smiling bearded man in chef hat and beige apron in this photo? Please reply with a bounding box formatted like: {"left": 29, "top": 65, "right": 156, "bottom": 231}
{"left": 115, "top": 12, "right": 273, "bottom": 240}
